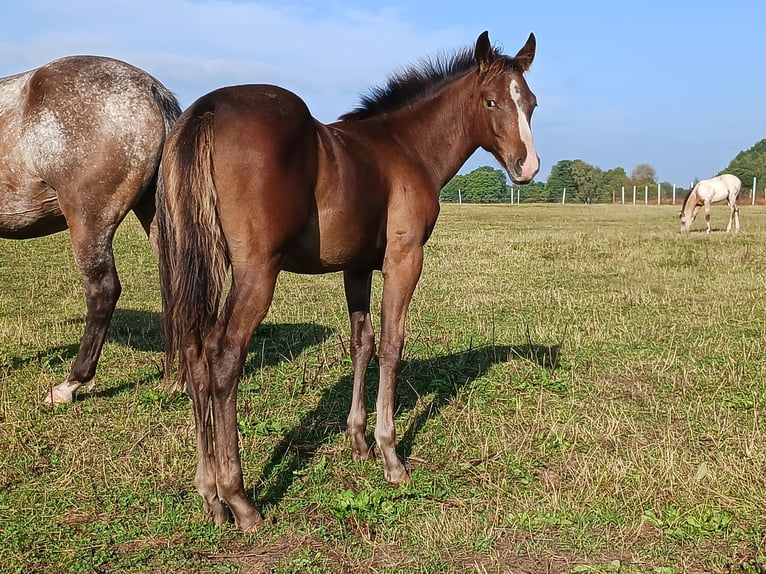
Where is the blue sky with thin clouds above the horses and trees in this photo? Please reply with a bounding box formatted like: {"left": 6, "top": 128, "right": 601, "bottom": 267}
{"left": 0, "top": 0, "right": 766, "bottom": 186}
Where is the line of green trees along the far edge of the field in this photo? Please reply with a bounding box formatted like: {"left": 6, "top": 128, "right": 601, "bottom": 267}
{"left": 440, "top": 139, "right": 766, "bottom": 203}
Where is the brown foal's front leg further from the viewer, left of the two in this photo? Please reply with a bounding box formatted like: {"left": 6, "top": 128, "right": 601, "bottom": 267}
{"left": 343, "top": 271, "right": 375, "bottom": 460}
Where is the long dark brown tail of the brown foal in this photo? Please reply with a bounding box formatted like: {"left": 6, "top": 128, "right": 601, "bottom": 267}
{"left": 157, "top": 107, "right": 229, "bottom": 389}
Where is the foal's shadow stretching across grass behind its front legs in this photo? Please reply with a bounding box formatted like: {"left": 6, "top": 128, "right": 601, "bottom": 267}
{"left": 251, "top": 344, "right": 560, "bottom": 511}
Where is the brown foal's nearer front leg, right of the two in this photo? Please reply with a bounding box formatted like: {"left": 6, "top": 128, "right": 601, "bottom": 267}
{"left": 375, "top": 235, "right": 423, "bottom": 484}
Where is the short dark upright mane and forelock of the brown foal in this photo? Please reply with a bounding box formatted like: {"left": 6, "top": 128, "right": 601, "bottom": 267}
{"left": 339, "top": 44, "right": 521, "bottom": 121}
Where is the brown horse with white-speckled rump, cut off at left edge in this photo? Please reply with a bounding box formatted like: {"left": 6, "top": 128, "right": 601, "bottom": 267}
{"left": 0, "top": 56, "right": 181, "bottom": 404}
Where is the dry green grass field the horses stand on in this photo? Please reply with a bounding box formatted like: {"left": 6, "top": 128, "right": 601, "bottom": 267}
{"left": 0, "top": 205, "right": 766, "bottom": 574}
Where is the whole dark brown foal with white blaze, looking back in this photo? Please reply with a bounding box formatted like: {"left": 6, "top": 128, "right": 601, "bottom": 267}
{"left": 158, "top": 32, "right": 540, "bottom": 530}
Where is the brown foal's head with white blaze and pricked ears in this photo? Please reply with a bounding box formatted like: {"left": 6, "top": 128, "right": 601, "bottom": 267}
{"left": 474, "top": 32, "right": 540, "bottom": 184}
